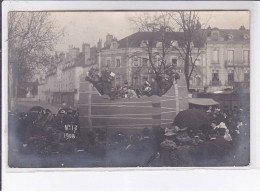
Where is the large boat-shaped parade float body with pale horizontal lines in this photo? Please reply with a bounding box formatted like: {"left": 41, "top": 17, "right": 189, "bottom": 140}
{"left": 78, "top": 71, "right": 188, "bottom": 135}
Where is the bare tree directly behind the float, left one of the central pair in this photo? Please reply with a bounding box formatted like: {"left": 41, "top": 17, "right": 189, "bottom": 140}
{"left": 129, "top": 12, "right": 177, "bottom": 86}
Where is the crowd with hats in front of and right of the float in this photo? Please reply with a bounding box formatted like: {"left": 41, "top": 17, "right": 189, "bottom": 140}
{"left": 78, "top": 106, "right": 249, "bottom": 167}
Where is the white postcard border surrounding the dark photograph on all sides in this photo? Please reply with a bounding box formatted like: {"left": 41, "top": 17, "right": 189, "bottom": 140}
{"left": 2, "top": 1, "right": 260, "bottom": 190}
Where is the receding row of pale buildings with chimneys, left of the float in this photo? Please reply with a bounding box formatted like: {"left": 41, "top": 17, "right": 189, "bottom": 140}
{"left": 38, "top": 43, "right": 97, "bottom": 106}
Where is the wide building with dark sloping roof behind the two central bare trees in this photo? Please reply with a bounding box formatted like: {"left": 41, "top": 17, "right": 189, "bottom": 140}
{"left": 98, "top": 32, "right": 206, "bottom": 89}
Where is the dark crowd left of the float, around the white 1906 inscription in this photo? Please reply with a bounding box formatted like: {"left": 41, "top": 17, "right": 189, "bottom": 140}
{"left": 9, "top": 103, "right": 79, "bottom": 154}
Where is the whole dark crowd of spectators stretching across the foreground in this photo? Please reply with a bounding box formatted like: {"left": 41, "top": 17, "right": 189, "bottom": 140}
{"left": 9, "top": 101, "right": 250, "bottom": 167}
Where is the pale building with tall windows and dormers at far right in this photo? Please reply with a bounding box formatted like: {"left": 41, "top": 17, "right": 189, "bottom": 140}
{"left": 205, "top": 26, "right": 250, "bottom": 91}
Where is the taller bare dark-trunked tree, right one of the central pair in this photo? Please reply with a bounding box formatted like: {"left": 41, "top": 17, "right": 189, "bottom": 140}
{"left": 168, "top": 11, "right": 207, "bottom": 90}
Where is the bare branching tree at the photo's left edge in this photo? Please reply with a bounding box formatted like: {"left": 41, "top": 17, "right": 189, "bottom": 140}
{"left": 8, "top": 12, "right": 63, "bottom": 107}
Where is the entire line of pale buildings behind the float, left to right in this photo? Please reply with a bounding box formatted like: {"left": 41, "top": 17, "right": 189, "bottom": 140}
{"left": 38, "top": 26, "right": 250, "bottom": 106}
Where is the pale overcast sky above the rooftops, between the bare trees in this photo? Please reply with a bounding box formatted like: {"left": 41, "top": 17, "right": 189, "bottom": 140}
{"left": 52, "top": 11, "right": 250, "bottom": 51}
